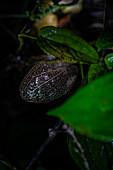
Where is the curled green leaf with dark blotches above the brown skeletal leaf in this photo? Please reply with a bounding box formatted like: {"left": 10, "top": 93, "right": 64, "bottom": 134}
{"left": 37, "top": 26, "right": 99, "bottom": 63}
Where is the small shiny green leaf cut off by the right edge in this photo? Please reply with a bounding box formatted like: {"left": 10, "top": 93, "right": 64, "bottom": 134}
{"left": 104, "top": 53, "right": 113, "bottom": 71}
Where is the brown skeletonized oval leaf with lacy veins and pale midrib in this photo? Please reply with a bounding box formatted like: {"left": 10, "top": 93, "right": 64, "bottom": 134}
{"left": 20, "top": 61, "right": 78, "bottom": 103}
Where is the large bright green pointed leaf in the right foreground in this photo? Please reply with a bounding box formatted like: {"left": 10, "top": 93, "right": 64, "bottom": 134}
{"left": 48, "top": 73, "right": 113, "bottom": 141}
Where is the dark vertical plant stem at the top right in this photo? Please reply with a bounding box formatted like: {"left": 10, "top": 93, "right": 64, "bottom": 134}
{"left": 103, "top": 0, "right": 109, "bottom": 31}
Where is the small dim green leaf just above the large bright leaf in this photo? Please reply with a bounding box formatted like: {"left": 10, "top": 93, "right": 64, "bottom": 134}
{"left": 88, "top": 62, "right": 107, "bottom": 83}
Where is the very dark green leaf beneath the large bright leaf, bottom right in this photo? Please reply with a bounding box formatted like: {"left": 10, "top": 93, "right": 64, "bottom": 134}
{"left": 68, "top": 132, "right": 113, "bottom": 170}
